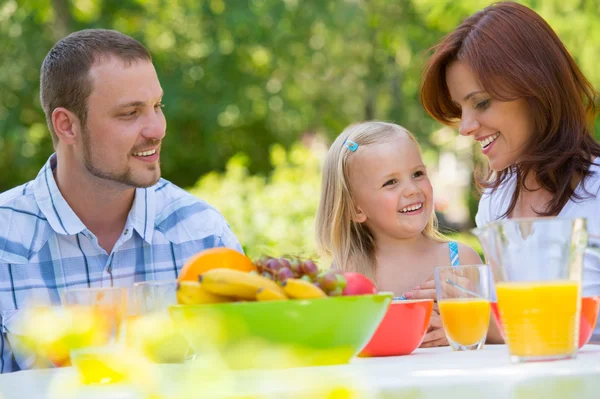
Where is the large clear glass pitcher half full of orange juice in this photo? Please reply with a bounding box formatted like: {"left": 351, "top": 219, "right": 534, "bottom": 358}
{"left": 476, "top": 218, "right": 588, "bottom": 363}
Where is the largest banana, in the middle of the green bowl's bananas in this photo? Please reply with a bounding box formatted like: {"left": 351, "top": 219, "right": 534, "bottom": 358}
{"left": 200, "top": 268, "right": 284, "bottom": 301}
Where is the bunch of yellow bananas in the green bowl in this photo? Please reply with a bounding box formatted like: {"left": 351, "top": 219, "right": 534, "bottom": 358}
{"left": 177, "top": 268, "right": 327, "bottom": 305}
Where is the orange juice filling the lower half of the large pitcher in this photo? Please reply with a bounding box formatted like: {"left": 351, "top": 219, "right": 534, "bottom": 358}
{"left": 496, "top": 280, "right": 580, "bottom": 360}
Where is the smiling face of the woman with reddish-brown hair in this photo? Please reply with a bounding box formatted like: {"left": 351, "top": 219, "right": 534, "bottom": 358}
{"left": 446, "top": 61, "right": 533, "bottom": 171}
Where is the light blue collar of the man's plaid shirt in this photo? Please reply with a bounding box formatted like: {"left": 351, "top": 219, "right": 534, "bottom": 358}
{"left": 33, "top": 153, "right": 156, "bottom": 244}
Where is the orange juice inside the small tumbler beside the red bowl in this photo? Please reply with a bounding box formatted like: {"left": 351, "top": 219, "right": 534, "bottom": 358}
{"left": 438, "top": 298, "right": 490, "bottom": 346}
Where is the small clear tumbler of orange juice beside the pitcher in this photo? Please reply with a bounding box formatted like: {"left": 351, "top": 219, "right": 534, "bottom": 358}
{"left": 435, "top": 265, "right": 491, "bottom": 351}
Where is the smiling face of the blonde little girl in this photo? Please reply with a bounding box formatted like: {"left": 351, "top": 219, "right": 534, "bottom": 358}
{"left": 348, "top": 133, "right": 433, "bottom": 241}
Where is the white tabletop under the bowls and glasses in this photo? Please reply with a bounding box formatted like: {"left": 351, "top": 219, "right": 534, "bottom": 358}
{"left": 0, "top": 345, "right": 600, "bottom": 399}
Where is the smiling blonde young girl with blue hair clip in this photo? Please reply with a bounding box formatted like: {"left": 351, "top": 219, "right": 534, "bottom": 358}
{"left": 316, "top": 121, "right": 482, "bottom": 346}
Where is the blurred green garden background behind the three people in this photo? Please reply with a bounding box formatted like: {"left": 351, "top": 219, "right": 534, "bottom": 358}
{"left": 0, "top": 0, "right": 600, "bottom": 256}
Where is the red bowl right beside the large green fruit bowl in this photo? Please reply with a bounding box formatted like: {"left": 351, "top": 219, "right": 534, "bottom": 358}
{"left": 359, "top": 299, "right": 433, "bottom": 357}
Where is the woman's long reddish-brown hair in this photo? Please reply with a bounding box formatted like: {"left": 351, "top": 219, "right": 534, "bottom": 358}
{"left": 420, "top": 2, "right": 600, "bottom": 216}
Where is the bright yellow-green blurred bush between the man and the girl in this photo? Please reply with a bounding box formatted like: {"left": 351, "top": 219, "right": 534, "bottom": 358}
{"left": 191, "top": 139, "right": 326, "bottom": 259}
